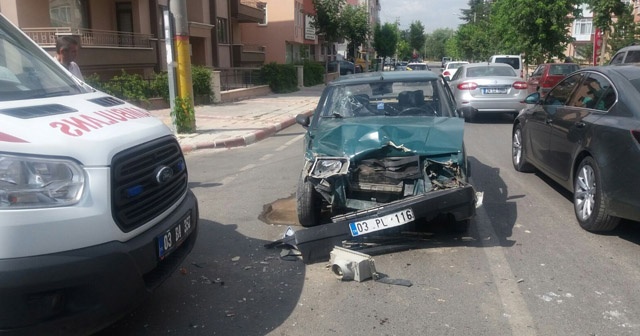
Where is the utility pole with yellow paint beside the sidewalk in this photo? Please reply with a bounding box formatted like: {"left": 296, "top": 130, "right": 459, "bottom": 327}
{"left": 169, "top": 0, "right": 196, "bottom": 130}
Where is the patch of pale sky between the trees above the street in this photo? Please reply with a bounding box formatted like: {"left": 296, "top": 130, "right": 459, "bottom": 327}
{"left": 380, "top": 0, "right": 469, "bottom": 34}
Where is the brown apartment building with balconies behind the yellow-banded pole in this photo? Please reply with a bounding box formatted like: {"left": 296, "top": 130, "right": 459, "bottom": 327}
{"left": 0, "top": 0, "right": 265, "bottom": 78}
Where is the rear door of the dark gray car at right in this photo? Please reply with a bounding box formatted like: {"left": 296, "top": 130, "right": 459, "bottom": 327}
{"left": 549, "top": 73, "right": 616, "bottom": 181}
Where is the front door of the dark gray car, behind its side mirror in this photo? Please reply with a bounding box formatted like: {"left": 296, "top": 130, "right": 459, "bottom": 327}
{"left": 526, "top": 74, "right": 583, "bottom": 170}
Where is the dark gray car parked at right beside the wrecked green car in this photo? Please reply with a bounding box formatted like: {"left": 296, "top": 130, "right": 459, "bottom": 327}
{"left": 512, "top": 66, "right": 640, "bottom": 231}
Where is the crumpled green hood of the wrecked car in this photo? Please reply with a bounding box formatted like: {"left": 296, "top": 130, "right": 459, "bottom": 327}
{"left": 311, "top": 116, "right": 464, "bottom": 158}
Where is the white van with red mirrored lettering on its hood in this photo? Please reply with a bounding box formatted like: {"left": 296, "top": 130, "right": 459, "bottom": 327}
{"left": 0, "top": 14, "right": 199, "bottom": 335}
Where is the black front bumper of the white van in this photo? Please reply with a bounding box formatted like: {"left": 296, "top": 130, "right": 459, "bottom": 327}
{"left": 0, "top": 191, "right": 199, "bottom": 335}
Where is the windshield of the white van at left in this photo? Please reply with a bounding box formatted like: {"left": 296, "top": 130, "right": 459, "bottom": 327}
{"left": 0, "top": 20, "right": 88, "bottom": 101}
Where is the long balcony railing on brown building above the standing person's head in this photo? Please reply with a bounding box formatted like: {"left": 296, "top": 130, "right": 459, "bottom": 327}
{"left": 22, "top": 27, "right": 153, "bottom": 48}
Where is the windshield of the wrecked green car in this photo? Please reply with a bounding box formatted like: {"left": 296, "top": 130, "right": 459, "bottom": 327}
{"left": 320, "top": 78, "right": 455, "bottom": 119}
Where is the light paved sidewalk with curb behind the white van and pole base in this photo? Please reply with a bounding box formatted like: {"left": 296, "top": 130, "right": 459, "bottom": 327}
{"left": 149, "top": 84, "right": 325, "bottom": 153}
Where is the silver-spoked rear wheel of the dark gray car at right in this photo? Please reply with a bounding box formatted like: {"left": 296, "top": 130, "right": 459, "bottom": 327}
{"left": 573, "top": 156, "right": 620, "bottom": 232}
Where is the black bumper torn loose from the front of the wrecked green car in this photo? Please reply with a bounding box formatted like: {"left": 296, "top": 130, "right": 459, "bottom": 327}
{"left": 266, "top": 185, "right": 476, "bottom": 264}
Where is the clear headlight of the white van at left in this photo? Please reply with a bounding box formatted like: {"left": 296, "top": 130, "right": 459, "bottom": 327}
{"left": 0, "top": 154, "right": 85, "bottom": 209}
